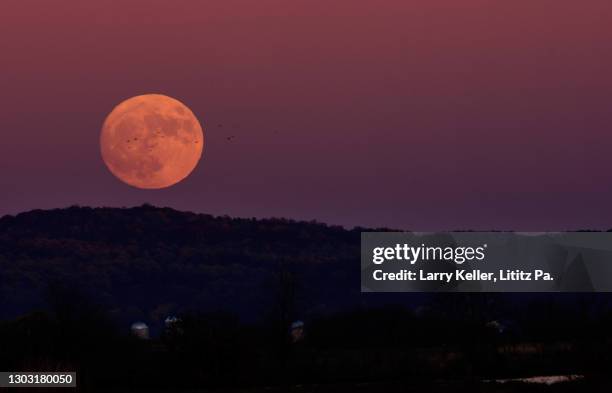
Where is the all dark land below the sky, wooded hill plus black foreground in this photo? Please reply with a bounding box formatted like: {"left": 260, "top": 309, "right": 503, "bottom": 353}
{"left": 0, "top": 207, "right": 612, "bottom": 393}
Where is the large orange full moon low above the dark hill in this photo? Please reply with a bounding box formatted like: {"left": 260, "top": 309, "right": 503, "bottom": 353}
{"left": 100, "top": 94, "right": 204, "bottom": 189}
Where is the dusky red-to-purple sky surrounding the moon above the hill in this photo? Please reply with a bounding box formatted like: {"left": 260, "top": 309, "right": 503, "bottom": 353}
{"left": 0, "top": 0, "right": 612, "bottom": 230}
